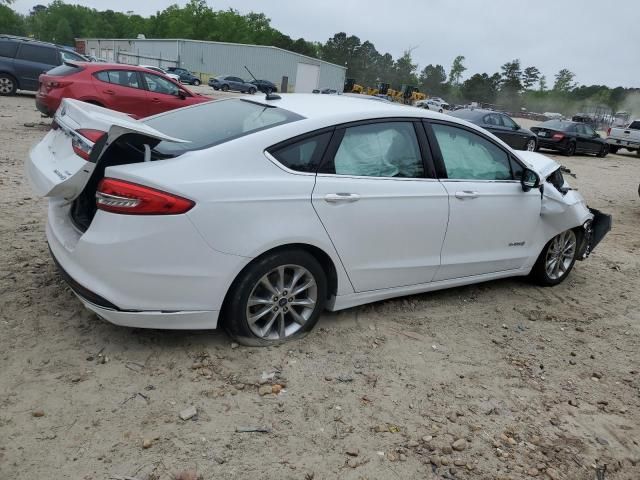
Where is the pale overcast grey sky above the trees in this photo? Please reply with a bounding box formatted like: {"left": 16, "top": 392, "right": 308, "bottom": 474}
{"left": 12, "top": 0, "right": 640, "bottom": 87}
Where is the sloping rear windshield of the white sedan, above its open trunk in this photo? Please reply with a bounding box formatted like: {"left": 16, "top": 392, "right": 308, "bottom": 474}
{"left": 145, "top": 99, "right": 304, "bottom": 156}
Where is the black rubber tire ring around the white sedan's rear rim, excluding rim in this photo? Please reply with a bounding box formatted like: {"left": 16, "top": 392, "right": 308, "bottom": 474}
{"left": 221, "top": 249, "right": 327, "bottom": 347}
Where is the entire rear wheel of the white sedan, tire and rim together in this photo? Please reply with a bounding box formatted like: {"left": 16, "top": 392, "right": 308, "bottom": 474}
{"left": 222, "top": 250, "right": 327, "bottom": 346}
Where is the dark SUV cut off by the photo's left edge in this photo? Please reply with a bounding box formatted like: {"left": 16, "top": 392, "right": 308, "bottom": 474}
{"left": 0, "top": 35, "right": 87, "bottom": 95}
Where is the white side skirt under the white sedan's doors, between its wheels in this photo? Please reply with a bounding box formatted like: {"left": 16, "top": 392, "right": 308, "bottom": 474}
{"left": 327, "top": 265, "right": 531, "bottom": 311}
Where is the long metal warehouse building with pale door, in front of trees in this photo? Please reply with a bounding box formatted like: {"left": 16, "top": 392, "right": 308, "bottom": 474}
{"left": 76, "top": 38, "right": 346, "bottom": 93}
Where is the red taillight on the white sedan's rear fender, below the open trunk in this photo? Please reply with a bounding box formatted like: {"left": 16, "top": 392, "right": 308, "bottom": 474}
{"left": 96, "top": 178, "right": 195, "bottom": 215}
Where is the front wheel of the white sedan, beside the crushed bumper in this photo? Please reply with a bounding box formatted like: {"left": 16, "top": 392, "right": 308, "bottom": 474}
{"left": 529, "top": 230, "right": 580, "bottom": 287}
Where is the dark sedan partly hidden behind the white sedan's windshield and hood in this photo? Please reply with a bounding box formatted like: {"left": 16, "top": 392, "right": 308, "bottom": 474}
{"left": 450, "top": 108, "right": 537, "bottom": 152}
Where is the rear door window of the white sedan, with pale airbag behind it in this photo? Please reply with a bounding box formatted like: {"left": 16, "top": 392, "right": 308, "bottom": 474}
{"left": 323, "top": 122, "right": 424, "bottom": 178}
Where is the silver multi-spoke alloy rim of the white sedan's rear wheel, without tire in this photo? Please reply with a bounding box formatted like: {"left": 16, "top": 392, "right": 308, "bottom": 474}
{"left": 246, "top": 265, "right": 318, "bottom": 340}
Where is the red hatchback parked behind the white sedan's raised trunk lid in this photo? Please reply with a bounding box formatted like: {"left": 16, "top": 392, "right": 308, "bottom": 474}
{"left": 36, "top": 62, "right": 212, "bottom": 118}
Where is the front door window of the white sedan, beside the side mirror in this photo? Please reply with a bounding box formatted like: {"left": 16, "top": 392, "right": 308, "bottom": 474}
{"left": 433, "top": 124, "right": 513, "bottom": 180}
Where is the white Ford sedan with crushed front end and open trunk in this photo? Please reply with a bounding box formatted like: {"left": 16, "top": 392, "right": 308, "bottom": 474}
{"left": 27, "top": 94, "right": 611, "bottom": 345}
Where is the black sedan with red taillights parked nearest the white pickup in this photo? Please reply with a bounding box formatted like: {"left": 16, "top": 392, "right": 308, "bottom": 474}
{"left": 531, "top": 120, "right": 609, "bottom": 157}
